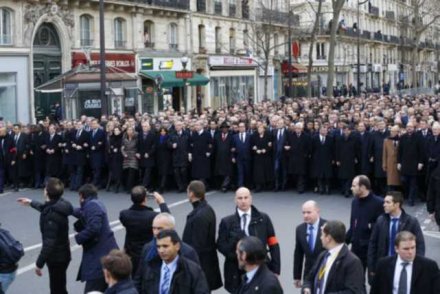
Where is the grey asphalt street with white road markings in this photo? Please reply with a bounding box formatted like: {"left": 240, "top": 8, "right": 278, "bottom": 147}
{"left": 0, "top": 190, "right": 440, "bottom": 294}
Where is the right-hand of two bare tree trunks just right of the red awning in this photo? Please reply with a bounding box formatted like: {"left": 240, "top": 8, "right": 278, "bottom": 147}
{"left": 327, "top": 0, "right": 346, "bottom": 96}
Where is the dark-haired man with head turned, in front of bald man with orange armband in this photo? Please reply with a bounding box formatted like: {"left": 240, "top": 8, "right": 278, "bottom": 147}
{"left": 236, "top": 236, "right": 283, "bottom": 294}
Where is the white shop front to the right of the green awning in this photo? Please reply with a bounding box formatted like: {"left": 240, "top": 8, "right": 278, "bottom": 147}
{"left": 208, "top": 56, "right": 258, "bottom": 109}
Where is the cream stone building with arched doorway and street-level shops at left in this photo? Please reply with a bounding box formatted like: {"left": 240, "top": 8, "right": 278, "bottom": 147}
{"left": 0, "top": 0, "right": 298, "bottom": 122}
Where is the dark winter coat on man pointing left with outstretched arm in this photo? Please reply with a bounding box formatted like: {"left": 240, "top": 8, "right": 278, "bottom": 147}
{"left": 31, "top": 198, "right": 73, "bottom": 268}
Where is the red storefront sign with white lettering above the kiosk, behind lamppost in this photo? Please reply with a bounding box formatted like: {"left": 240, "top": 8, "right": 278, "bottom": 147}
{"left": 72, "top": 52, "right": 136, "bottom": 73}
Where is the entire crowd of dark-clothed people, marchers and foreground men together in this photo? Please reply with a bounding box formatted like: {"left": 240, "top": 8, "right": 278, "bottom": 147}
{"left": 0, "top": 95, "right": 440, "bottom": 294}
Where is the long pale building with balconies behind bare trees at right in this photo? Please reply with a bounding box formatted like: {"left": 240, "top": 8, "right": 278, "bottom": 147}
{"left": 291, "top": 0, "right": 440, "bottom": 91}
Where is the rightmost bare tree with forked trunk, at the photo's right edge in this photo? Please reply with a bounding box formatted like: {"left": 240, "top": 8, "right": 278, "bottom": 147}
{"left": 410, "top": 0, "right": 440, "bottom": 87}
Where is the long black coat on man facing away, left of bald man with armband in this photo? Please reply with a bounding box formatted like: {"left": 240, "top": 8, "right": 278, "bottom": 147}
{"left": 182, "top": 200, "right": 222, "bottom": 290}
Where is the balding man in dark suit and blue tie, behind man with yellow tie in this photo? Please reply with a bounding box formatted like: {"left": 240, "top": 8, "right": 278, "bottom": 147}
{"left": 293, "top": 200, "right": 326, "bottom": 288}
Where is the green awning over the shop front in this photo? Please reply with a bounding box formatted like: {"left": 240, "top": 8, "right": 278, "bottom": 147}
{"left": 139, "top": 70, "right": 209, "bottom": 88}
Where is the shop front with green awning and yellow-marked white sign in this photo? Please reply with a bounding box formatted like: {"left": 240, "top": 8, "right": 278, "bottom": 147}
{"left": 139, "top": 57, "right": 210, "bottom": 113}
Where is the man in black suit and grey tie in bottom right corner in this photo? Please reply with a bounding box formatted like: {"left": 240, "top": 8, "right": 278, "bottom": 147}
{"left": 370, "top": 231, "right": 439, "bottom": 294}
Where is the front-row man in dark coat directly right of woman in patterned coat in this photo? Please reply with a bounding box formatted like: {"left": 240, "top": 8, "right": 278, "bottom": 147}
{"left": 136, "top": 121, "right": 156, "bottom": 189}
